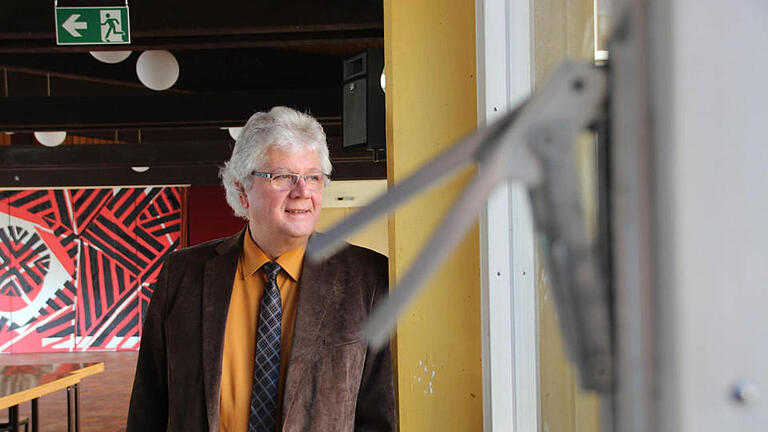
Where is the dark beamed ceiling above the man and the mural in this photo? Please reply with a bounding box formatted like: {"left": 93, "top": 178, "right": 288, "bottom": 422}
{"left": 0, "top": 0, "right": 386, "bottom": 187}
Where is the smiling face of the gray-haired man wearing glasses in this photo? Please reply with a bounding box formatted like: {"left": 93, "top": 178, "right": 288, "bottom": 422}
{"left": 241, "top": 147, "right": 323, "bottom": 254}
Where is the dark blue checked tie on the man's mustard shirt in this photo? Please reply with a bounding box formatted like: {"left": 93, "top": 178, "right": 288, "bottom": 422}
{"left": 248, "top": 261, "right": 283, "bottom": 432}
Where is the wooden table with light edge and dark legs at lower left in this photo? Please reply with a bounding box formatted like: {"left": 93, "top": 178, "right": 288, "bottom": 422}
{"left": 0, "top": 362, "right": 104, "bottom": 432}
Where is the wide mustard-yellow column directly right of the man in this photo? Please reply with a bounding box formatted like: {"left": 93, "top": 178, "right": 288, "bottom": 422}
{"left": 384, "top": 0, "right": 482, "bottom": 432}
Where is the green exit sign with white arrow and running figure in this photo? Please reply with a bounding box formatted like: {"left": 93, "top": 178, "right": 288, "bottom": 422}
{"left": 56, "top": 6, "right": 131, "bottom": 45}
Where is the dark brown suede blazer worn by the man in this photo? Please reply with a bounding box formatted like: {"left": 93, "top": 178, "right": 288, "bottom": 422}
{"left": 127, "top": 231, "right": 397, "bottom": 432}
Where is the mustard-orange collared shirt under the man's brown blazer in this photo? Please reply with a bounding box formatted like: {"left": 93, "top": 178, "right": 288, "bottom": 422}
{"left": 219, "top": 230, "right": 305, "bottom": 432}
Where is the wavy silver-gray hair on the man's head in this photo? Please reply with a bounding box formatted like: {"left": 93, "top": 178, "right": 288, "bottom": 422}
{"left": 219, "top": 106, "right": 331, "bottom": 219}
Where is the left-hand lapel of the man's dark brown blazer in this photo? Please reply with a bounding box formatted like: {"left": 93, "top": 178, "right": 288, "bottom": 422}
{"left": 201, "top": 230, "right": 245, "bottom": 431}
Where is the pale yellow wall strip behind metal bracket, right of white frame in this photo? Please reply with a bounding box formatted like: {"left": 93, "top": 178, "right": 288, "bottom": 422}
{"left": 533, "top": 0, "right": 600, "bottom": 432}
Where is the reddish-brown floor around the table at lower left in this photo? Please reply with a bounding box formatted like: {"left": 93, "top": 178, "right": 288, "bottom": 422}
{"left": 0, "top": 351, "right": 138, "bottom": 432}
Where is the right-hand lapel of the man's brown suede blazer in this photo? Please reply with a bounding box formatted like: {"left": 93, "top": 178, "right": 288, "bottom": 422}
{"left": 282, "top": 238, "right": 336, "bottom": 427}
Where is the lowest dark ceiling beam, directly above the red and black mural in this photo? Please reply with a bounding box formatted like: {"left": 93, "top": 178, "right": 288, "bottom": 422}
{"left": 0, "top": 138, "right": 387, "bottom": 188}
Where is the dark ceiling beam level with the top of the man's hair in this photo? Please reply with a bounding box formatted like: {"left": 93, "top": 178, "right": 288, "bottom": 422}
{"left": 0, "top": 87, "right": 342, "bottom": 131}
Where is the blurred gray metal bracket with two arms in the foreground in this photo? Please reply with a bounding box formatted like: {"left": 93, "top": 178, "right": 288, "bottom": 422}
{"left": 307, "top": 61, "right": 611, "bottom": 391}
